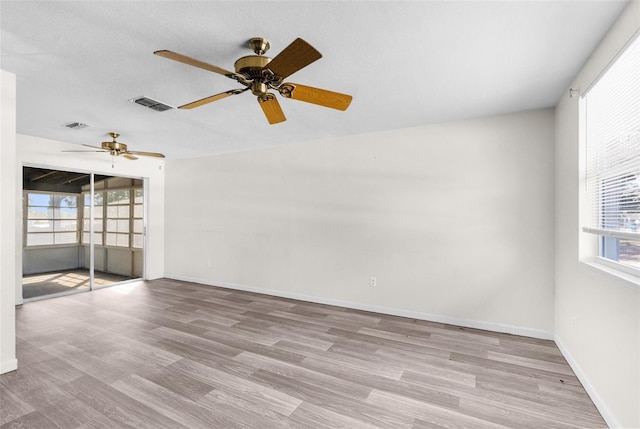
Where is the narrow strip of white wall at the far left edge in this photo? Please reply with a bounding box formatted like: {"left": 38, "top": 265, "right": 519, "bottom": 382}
{"left": 0, "top": 70, "right": 18, "bottom": 374}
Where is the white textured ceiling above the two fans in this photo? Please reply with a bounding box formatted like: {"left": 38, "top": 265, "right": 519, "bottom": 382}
{"left": 0, "top": 0, "right": 626, "bottom": 158}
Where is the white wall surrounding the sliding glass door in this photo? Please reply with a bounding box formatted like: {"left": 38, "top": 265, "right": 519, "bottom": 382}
{"left": 15, "top": 130, "right": 165, "bottom": 300}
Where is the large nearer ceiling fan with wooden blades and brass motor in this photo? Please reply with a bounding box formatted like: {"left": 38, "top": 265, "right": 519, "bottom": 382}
{"left": 154, "top": 37, "right": 352, "bottom": 124}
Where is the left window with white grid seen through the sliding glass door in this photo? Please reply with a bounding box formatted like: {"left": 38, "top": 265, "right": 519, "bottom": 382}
{"left": 26, "top": 192, "right": 78, "bottom": 246}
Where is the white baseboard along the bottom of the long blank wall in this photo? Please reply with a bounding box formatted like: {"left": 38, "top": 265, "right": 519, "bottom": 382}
{"left": 166, "top": 274, "right": 554, "bottom": 340}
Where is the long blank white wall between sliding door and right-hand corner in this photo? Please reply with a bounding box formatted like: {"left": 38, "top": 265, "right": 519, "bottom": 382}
{"left": 165, "top": 109, "right": 554, "bottom": 338}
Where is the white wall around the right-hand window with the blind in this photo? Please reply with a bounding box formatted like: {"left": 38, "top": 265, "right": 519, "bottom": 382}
{"left": 555, "top": 1, "right": 640, "bottom": 428}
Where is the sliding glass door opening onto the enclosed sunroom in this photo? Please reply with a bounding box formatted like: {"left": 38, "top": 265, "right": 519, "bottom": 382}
{"left": 22, "top": 166, "right": 145, "bottom": 300}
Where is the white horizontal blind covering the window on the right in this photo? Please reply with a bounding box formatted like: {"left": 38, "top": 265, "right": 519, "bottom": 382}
{"left": 583, "top": 37, "right": 640, "bottom": 240}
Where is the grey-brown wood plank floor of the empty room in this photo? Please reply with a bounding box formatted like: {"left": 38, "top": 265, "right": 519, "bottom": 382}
{"left": 0, "top": 279, "right": 606, "bottom": 429}
